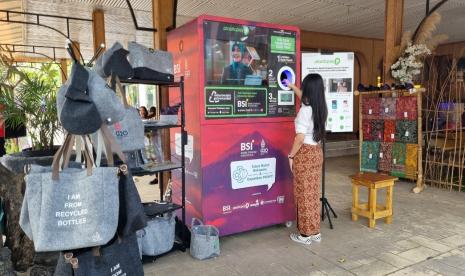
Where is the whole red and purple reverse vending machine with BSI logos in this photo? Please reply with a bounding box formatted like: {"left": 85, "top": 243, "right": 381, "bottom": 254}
{"left": 168, "top": 15, "right": 300, "bottom": 235}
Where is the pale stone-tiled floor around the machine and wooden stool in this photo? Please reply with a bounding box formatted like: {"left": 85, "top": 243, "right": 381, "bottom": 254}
{"left": 143, "top": 156, "right": 465, "bottom": 276}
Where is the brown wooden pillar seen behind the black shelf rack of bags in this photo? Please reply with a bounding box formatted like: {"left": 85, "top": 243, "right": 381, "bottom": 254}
{"left": 152, "top": 0, "right": 174, "bottom": 193}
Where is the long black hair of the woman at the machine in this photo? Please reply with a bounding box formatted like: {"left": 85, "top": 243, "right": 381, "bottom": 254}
{"left": 302, "top": 74, "right": 328, "bottom": 142}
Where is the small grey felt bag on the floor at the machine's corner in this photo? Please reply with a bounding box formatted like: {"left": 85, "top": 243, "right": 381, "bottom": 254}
{"left": 190, "top": 218, "right": 220, "bottom": 260}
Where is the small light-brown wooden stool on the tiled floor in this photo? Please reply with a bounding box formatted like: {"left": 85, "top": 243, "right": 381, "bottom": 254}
{"left": 350, "top": 172, "right": 398, "bottom": 228}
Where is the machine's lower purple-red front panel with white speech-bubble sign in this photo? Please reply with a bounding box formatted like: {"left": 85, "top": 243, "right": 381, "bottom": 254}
{"left": 202, "top": 122, "right": 295, "bottom": 235}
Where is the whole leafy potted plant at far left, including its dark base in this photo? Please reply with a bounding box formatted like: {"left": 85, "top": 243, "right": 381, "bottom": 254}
{"left": 0, "top": 47, "right": 61, "bottom": 274}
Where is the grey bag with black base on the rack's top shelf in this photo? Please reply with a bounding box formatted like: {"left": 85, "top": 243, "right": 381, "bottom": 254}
{"left": 128, "top": 42, "right": 174, "bottom": 82}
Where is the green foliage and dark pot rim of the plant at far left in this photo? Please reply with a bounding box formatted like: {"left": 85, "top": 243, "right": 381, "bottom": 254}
{"left": 0, "top": 50, "right": 60, "bottom": 173}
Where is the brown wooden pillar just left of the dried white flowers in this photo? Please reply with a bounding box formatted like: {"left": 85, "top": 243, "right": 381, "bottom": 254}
{"left": 383, "top": 0, "right": 404, "bottom": 83}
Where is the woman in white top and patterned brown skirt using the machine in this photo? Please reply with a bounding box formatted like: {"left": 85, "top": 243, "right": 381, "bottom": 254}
{"left": 286, "top": 74, "right": 328, "bottom": 244}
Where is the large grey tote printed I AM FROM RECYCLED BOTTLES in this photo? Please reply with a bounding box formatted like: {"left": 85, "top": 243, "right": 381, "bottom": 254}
{"left": 20, "top": 134, "right": 119, "bottom": 252}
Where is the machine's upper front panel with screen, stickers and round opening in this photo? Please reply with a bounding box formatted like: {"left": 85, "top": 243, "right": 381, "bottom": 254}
{"left": 203, "top": 20, "right": 297, "bottom": 119}
